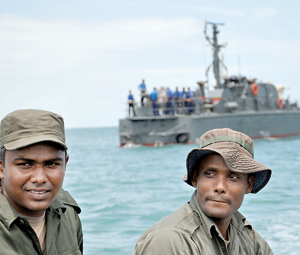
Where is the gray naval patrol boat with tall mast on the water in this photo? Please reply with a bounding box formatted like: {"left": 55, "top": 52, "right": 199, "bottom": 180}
{"left": 119, "top": 22, "right": 300, "bottom": 147}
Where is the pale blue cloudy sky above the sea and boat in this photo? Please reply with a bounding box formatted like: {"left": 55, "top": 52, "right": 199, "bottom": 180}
{"left": 0, "top": 0, "right": 300, "bottom": 128}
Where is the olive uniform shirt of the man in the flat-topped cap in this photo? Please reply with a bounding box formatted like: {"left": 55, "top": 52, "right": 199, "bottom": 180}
{"left": 0, "top": 190, "right": 83, "bottom": 255}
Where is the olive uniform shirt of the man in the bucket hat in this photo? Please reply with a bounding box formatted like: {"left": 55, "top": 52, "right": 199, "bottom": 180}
{"left": 135, "top": 191, "right": 273, "bottom": 255}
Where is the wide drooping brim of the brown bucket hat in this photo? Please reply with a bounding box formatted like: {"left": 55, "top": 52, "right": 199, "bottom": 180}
{"left": 185, "top": 142, "right": 271, "bottom": 193}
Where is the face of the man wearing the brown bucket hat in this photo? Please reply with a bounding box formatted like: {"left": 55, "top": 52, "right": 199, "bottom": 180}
{"left": 193, "top": 154, "right": 254, "bottom": 224}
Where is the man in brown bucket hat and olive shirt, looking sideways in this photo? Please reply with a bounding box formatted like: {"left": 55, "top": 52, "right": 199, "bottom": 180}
{"left": 135, "top": 128, "right": 273, "bottom": 255}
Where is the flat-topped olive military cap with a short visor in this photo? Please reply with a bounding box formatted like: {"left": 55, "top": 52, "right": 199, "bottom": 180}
{"left": 0, "top": 110, "right": 67, "bottom": 150}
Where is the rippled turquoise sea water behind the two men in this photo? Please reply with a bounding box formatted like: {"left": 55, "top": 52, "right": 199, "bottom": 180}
{"left": 64, "top": 127, "right": 300, "bottom": 255}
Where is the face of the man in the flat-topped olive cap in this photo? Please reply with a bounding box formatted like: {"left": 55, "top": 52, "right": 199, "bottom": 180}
{"left": 0, "top": 143, "right": 68, "bottom": 217}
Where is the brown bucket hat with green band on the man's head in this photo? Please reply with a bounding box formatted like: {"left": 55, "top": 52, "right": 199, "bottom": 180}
{"left": 183, "top": 128, "right": 271, "bottom": 193}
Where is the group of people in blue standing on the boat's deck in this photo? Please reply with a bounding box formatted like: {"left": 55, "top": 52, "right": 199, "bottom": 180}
{"left": 128, "top": 79, "right": 195, "bottom": 116}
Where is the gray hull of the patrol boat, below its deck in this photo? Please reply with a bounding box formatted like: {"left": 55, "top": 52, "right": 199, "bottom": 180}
{"left": 119, "top": 110, "right": 300, "bottom": 146}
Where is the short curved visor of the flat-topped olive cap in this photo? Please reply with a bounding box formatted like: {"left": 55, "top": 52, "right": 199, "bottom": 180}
{"left": 5, "top": 135, "right": 68, "bottom": 150}
